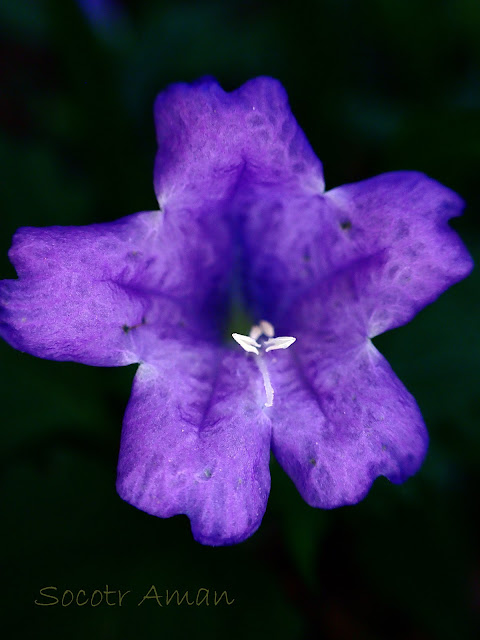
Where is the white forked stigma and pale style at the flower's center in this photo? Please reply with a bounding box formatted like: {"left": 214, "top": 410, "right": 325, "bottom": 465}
{"left": 232, "top": 320, "right": 296, "bottom": 407}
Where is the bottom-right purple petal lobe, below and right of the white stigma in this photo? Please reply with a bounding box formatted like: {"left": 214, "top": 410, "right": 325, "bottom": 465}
{"left": 271, "top": 341, "right": 428, "bottom": 509}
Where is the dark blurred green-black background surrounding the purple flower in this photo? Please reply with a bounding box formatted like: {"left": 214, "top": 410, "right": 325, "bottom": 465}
{"left": 0, "top": 0, "right": 480, "bottom": 640}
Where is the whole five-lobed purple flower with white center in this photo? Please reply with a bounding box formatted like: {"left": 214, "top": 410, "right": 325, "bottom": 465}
{"left": 0, "top": 78, "right": 472, "bottom": 545}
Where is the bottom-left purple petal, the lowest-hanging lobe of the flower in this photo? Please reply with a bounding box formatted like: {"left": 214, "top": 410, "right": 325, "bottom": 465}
{"left": 117, "top": 342, "right": 271, "bottom": 545}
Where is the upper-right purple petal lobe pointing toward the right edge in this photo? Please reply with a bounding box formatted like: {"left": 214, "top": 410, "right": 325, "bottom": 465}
{"left": 326, "top": 171, "right": 473, "bottom": 337}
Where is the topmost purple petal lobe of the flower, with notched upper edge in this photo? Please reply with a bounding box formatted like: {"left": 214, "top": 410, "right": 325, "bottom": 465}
{"left": 154, "top": 78, "right": 323, "bottom": 210}
